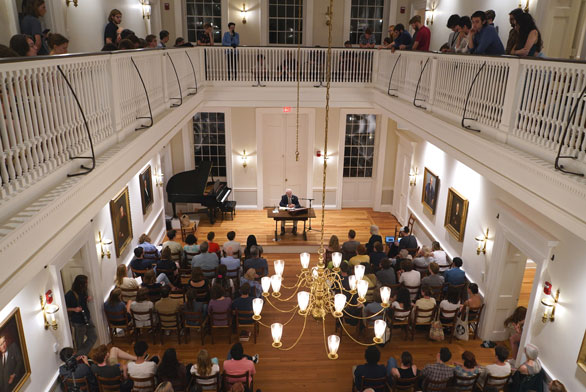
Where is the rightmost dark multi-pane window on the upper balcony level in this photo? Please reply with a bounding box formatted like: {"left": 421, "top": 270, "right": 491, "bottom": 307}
{"left": 350, "top": 0, "right": 386, "bottom": 45}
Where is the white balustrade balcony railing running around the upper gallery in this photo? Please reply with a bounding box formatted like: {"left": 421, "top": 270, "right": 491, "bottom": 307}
{"left": 0, "top": 47, "right": 586, "bottom": 207}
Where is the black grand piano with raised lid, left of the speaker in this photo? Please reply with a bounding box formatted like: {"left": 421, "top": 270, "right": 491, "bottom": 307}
{"left": 166, "top": 161, "right": 232, "bottom": 224}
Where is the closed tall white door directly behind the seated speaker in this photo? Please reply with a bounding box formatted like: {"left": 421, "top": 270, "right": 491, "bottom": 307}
{"left": 262, "top": 113, "right": 309, "bottom": 207}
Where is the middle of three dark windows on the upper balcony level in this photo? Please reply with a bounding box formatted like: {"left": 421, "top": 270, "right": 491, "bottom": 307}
{"left": 269, "top": 0, "right": 303, "bottom": 45}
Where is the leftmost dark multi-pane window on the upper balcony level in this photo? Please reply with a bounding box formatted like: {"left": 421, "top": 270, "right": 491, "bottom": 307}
{"left": 186, "top": 0, "right": 222, "bottom": 43}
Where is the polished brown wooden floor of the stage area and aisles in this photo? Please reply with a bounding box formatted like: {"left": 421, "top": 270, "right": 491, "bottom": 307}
{"left": 116, "top": 209, "right": 504, "bottom": 392}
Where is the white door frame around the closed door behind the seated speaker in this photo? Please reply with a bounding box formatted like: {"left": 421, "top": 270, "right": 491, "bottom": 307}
{"left": 255, "top": 108, "right": 315, "bottom": 210}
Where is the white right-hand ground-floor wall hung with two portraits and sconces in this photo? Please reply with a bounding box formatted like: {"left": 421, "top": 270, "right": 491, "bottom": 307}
{"left": 408, "top": 136, "right": 586, "bottom": 391}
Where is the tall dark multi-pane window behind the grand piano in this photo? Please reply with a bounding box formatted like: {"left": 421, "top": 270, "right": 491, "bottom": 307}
{"left": 193, "top": 113, "right": 226, "bottom": 177}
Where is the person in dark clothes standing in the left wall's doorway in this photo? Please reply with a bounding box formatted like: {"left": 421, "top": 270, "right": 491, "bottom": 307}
{"left": 65, "top": 275, "right": 97, "bottom": 355}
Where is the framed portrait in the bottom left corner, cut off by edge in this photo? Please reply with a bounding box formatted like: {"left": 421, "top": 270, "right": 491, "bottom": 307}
{"left": 0, "top": 308, "right": 31, "bottom": 392}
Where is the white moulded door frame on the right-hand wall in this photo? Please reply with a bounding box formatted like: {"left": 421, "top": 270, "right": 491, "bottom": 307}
{"left": 481, "top": 200, "right": 559, "bottom": 365}
